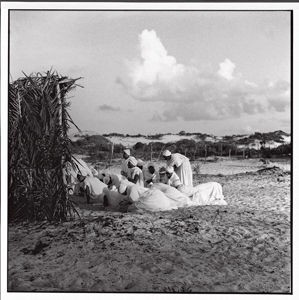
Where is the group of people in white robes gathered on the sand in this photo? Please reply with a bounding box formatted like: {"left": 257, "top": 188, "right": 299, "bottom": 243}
{"left": 64, "top": 149, "right": 227, "bottom": 211}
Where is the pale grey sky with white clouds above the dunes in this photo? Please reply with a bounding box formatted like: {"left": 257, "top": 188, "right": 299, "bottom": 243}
{"left": 10, "top": 11, "right": 291, "bottom": 135}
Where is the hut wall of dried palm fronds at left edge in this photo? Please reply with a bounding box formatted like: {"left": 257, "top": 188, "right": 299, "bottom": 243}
{"left": 8, "top": 71, "right": 79, "bottom": 220}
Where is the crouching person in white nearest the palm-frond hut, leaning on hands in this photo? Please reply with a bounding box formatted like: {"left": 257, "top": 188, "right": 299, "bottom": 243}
{"left": 77, "top": 174, "right": 107, "bottom": 204}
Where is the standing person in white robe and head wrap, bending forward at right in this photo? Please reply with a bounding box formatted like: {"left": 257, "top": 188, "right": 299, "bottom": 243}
{"left": 163, "top": 150, "right": 193, "bottom": 186}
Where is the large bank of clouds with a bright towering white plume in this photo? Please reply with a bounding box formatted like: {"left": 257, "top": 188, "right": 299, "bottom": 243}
{"left": 117, "top": 30, "right": 290, "bottom": 121}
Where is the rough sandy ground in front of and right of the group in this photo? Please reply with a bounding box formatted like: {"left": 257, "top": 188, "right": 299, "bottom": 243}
{"left": 8, "top": 159, "right": 291, "bottom": 293}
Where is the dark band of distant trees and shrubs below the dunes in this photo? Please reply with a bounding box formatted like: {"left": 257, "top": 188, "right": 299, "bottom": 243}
{"left": 72, "top": 132, "right": 292, "bottom": 161}
